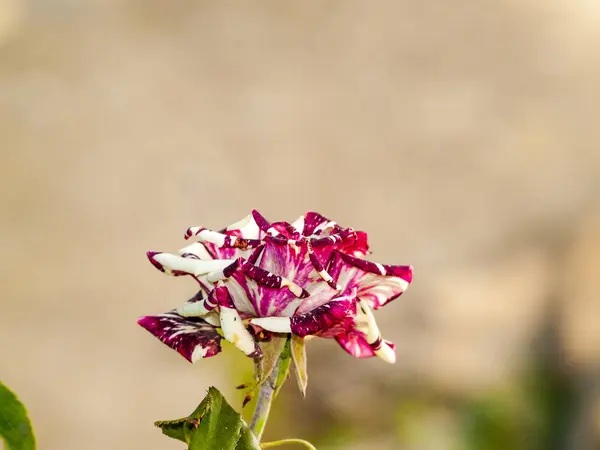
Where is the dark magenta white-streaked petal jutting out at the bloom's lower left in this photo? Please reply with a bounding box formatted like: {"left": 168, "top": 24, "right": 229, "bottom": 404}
{"left": 138, "top": 312, "right": 222, "bottom": 362}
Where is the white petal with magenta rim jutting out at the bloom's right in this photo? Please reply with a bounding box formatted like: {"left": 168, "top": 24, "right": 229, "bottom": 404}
{"left": 329, "top": 251, "right": 412, "bottom": 309}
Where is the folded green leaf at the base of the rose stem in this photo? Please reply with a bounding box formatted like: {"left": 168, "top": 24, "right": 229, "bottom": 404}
{"left": 155, "top": 387, "right": 260, "bottom": 450}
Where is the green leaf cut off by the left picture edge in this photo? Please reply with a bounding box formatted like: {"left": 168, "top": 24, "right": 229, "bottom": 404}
{"left": 0, "top": 383, "right": 35, "bottom": 450}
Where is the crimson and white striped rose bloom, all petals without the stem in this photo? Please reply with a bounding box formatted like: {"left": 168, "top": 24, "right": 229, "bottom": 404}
{"left": 139, "top": 211, "right": 412, "bottom": 362}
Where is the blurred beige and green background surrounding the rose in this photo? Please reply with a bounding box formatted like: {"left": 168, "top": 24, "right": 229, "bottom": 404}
{"left": 0, "top": 0, "right": 600, "bottom": 450}
